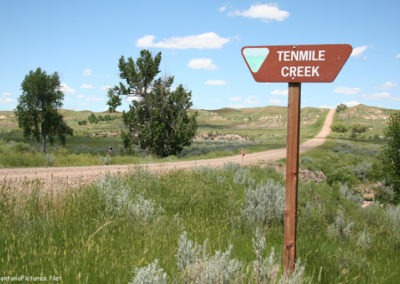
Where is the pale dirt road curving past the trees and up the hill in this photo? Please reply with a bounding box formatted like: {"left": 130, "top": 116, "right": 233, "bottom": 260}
{"left": 0, "top": 110, "right": 335, "bottom": 188}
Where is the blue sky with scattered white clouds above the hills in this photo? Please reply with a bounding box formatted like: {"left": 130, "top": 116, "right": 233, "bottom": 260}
{"left": 0, "top": 0, "right": 400, "bottom": 111}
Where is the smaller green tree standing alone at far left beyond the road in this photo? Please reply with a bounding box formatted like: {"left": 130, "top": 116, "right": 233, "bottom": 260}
{"left": 15, "top": 68, "right": 73, "bottom": 152}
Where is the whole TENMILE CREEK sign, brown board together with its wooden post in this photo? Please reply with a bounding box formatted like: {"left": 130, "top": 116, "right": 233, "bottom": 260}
{"left": 242, "top": 44, "right": 353, "bottom": 274}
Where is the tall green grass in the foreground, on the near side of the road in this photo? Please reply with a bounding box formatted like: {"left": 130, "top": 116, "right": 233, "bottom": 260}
{"left": 0, "top": 165, "right": 400, "bottom": 283}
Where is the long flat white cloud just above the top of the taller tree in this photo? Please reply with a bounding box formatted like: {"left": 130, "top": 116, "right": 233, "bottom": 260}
{"left": 136, "top": 32, "right": 229, "bottom": 49}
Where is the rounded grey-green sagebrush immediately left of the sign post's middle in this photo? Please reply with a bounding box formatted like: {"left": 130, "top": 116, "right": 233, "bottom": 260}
{"left": 242, "top": 181, "right": 285, "bottom": 225}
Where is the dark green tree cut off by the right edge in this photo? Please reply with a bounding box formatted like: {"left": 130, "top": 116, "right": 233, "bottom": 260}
{"left": 383, "top": 111, "right": 400, "bottom": 202}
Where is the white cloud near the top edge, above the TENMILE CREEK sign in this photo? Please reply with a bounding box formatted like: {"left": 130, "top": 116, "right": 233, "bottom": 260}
{"left": 229, "top": 3, "right": 289, "bottom": 22}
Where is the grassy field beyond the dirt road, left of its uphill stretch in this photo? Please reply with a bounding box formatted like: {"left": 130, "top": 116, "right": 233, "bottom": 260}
{"left": 0, "top": 107, "right": 327, "bottom": 167}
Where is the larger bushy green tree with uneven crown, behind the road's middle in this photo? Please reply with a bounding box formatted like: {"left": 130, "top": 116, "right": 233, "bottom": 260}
{"left": 109, "top": 50, "right": 197, "bottom": 157}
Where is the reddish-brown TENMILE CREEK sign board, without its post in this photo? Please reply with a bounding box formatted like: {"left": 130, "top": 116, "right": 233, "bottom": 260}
{"left": 242, "top": 44, "right": 353, "bottom": 83}
